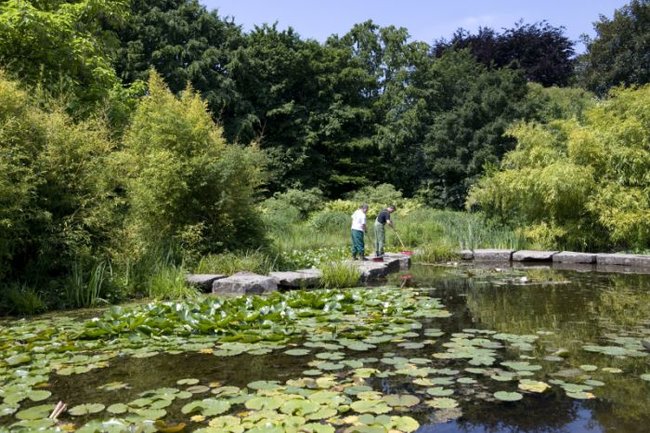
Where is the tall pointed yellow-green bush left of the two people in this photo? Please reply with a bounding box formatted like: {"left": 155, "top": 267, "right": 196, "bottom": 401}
{"left": 117, "top": 73, "right": 263, "bottom": 257}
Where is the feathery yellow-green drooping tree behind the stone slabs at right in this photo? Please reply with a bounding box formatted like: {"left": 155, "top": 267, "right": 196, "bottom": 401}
{"left": 468, "top": 86, "right": 650, "bottom": 250}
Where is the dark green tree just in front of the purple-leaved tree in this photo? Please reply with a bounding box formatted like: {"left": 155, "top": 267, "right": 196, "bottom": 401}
{"left": 420, "top": 50, "right": 528, "bottom": 208}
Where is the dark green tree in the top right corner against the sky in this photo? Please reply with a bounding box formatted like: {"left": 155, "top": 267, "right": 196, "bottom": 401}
{"left": 579, "top": 0, "right": 650, "bottom": 96}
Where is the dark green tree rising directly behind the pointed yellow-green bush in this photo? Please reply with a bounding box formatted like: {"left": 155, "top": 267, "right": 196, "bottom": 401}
{"left": 109, "top": 0, "right": 244, "bottom": 138}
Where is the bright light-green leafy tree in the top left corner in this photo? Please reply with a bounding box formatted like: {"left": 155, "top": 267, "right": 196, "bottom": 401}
{"left": 0, "top": 0, "right": 129, "bottom": 107}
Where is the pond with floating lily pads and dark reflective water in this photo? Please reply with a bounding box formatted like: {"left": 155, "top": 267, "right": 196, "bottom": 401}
{"left": 0, "top": 266, "right": 650, "bottom": 433}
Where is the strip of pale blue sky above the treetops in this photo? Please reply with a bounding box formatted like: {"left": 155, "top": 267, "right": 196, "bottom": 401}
{"left": 199, "top": 0, "right": 628, "bottom": 52}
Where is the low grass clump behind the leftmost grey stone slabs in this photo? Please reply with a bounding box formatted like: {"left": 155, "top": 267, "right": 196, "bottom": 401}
{"left": 195, "top": 250, "right": 278, "bottom": 275}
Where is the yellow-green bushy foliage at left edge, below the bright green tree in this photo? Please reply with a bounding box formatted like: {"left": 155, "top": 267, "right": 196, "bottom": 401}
{"left": 0, "top": 71, "right": 119, "bottom": 286}
